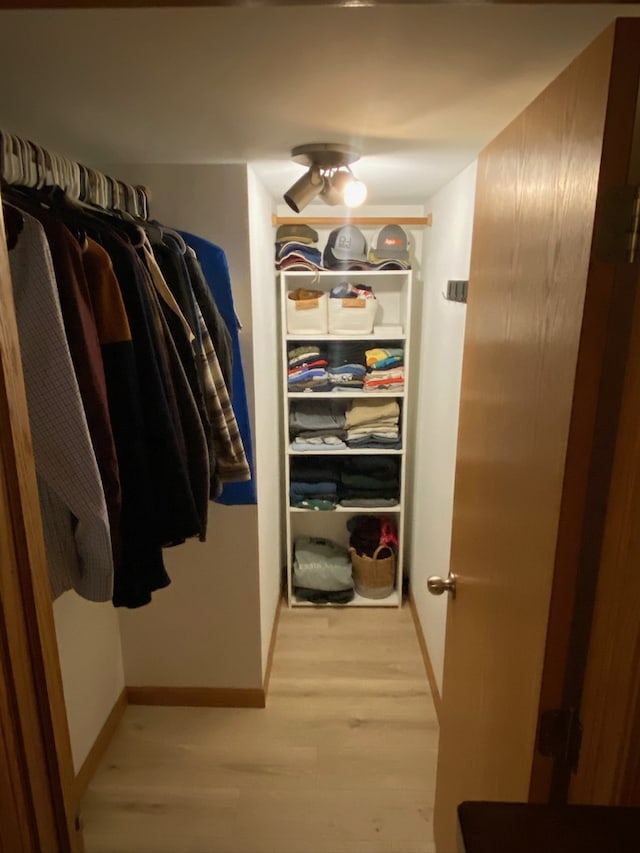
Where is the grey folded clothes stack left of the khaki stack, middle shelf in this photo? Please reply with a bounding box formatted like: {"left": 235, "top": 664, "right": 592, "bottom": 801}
{"left": 289, "top": 400, "right": 347, "bottom": 451}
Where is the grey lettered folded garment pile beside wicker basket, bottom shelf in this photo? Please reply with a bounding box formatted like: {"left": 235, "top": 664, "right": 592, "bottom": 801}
{"left": 293, "top": 536, "right": 353, "bottom": 604}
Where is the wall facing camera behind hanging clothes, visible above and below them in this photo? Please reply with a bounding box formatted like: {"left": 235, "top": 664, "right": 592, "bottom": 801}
{"left": 109, "top": 164, "right": 262, "bottom": 688}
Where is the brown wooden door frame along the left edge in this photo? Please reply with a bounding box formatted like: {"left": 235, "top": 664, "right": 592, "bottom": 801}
{"left": 0, "top": 205, "right": 84, "bottom": 853}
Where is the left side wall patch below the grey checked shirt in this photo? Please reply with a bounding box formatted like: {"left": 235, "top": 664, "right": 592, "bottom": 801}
{"left": 53, "top": 590, "right": 124, "bottom": 773}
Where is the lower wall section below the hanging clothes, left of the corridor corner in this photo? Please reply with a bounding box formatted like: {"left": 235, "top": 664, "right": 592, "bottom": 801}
{"left": 119, "top": 504, "right": 262, "bottom": 688}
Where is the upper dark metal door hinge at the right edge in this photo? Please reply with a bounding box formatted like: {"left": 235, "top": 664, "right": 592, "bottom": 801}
{"left": 593, "top": 186, "right": 640, "bottom": 264}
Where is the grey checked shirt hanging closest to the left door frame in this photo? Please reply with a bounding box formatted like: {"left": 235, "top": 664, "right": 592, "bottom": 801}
{"left": 9, "top": 213, "right": 113, "bottom": 601}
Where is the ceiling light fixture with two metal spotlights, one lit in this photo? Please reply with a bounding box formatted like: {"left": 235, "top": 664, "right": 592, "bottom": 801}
{"left": 284, "top": 142, "right": 367, "bottom": 213}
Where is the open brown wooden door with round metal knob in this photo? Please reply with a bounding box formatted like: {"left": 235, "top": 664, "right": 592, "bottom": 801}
{"left": 434, "top": 20, "right": 640, "bottom": 853}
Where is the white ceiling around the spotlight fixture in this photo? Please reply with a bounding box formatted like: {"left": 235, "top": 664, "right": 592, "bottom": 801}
{"left": 0, "top": 4, "right": 640, "bottom": 204}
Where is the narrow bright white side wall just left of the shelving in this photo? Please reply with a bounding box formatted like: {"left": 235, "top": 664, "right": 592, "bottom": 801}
{"left": 247, "top": 167, "right": 282, "bottom": 678}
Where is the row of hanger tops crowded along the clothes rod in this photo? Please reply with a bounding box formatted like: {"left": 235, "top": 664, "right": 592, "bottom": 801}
{"left": 0, "top": 130, "right": 149, "bottom": 219}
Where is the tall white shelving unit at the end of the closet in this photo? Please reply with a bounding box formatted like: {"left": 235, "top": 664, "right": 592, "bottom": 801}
{"left": 280, "top": 270, "right": 411, "bottom": 607}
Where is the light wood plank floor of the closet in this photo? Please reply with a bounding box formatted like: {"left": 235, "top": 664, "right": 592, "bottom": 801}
{"left": 81, "top": 607, "right": 438, "bottom": 853}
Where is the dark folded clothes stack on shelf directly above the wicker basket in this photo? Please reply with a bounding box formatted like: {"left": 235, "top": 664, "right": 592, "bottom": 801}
{"left": 339, "top": 456, "right": 400, "bottom": 507}
